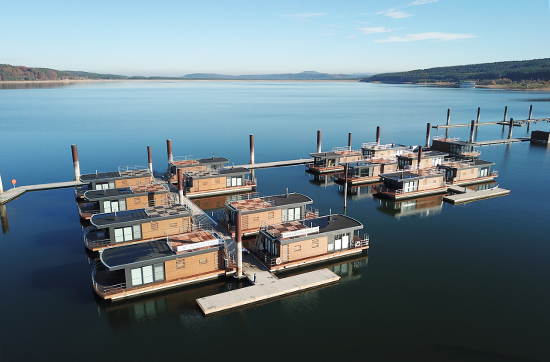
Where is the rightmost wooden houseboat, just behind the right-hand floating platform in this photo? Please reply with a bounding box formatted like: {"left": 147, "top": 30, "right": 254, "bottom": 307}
{"left": 438, "top": 159, "right": 498, "bottom": 186}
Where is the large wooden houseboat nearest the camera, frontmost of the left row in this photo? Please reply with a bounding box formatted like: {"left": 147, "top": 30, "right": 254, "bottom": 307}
{"left": 92, "top": 230, "right": 228, "bottom": 300}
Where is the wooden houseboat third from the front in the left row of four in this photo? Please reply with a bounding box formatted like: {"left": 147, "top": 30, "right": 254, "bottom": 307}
{"left": 78, "top": 184, "right": 170, "bottom": 220}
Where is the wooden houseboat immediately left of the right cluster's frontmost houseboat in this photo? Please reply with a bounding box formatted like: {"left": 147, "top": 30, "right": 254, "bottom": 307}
{"left": 335, "top": 158, "right": 397, "bottom": 186}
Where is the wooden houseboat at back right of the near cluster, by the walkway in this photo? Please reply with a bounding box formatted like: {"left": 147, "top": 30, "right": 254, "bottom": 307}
{"left": 183, "top": 167, "right": 256, "bottom": 198}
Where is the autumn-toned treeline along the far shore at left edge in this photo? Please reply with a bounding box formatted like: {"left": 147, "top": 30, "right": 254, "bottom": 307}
{"left": 0, "top": 64, "right": 126, "bottom": 81}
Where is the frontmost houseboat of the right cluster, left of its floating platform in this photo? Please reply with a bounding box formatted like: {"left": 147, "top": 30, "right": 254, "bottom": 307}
{"left": 374, "top": 168, "right": 448, "bottom": 200}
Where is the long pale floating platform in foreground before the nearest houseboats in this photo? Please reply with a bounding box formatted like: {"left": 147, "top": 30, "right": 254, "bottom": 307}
{"left": 197, "top": 269, "right": 340, "bottom": 315}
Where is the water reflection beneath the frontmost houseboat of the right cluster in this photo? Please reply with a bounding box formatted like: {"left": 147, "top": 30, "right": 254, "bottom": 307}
{"left": 378, "top": 195, "right": 443, "bottom": 218}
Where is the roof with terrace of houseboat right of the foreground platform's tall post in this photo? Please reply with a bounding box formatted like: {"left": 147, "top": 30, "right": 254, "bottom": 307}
{"left": 266, "top": 214, "right": 363, "bottom": 244}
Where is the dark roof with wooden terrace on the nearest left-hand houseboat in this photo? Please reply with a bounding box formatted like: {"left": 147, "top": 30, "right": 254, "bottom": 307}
{"left": 99, "top": 230, "right": 220, "bottom": 270}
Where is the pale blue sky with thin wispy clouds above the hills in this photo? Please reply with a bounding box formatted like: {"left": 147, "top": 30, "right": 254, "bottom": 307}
{"left": 0, "top": 0, "right": 550, "bottom": 76}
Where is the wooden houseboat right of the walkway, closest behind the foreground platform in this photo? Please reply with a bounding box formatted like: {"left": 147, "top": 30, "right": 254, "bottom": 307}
{"left": 250, "top": 215, "right": 369, "bottom": 271}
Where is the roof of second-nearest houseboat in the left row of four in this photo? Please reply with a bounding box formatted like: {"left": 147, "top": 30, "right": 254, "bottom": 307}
{"left": 90, "top": 205, "right": 191, "bottom": 228}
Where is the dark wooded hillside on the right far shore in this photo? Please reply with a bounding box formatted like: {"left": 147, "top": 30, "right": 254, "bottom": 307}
{"left": 361, "top": 58, "right": 550, "bottom": 84}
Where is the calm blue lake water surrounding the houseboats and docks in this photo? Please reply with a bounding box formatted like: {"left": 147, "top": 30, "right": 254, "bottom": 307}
{"left": 0, "top": 82, "right": 550, "bottom": 361}
